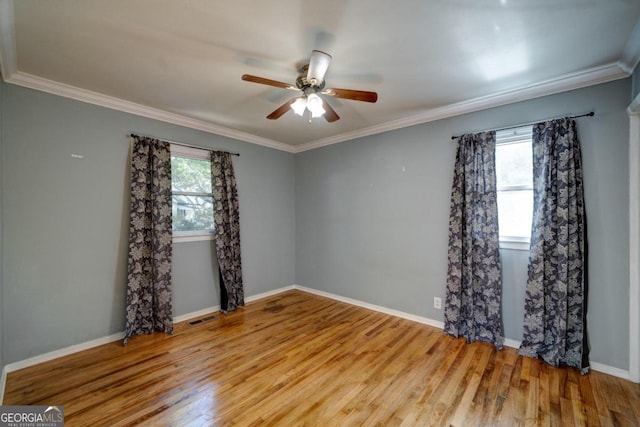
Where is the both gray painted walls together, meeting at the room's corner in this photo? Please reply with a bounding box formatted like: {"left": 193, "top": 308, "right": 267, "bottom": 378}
{"left": 0, "top": 79, "right": 631, "bottom": 369}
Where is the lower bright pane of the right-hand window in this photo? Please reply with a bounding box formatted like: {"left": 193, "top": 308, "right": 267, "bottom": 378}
{"left": 498, "top": 190, "right": 533, "bottom": 238}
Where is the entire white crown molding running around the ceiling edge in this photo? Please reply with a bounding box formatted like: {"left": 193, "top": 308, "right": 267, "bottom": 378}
{"left": 0, "top": 0, "right": 640, "bottom": 157}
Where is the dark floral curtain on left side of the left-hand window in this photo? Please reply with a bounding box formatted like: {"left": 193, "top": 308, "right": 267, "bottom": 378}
{"left": 124, "top": 135, "right": 173, "bottom": 344}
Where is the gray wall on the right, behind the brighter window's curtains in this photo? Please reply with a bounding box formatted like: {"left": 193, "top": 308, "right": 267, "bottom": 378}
{"left": 295, "top": 79, "right": 631, "bottom": 369}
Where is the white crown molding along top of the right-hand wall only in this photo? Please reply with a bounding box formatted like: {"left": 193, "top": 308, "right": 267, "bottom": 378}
{"left": 295, "top": 63, "right": 629, "bottom": 153}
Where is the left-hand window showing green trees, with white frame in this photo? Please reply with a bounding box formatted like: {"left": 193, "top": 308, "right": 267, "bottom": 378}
{"left": 171, "top": 144, "right": 214, "bottom": 242}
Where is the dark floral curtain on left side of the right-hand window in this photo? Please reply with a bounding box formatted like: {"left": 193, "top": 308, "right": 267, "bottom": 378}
{"left": 444, "top": 131, "right": 504, "bottom": 349}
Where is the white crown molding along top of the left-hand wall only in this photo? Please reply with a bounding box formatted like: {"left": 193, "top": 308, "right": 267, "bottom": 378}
{"left": 5, "top": 71, "right": 293, "bottom": 153}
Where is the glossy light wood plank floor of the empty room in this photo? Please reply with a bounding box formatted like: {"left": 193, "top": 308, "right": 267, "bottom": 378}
{"left": 4, "top": 291, "right": 640, "bottom": 426}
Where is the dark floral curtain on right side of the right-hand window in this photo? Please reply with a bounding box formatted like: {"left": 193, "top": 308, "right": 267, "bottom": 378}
{"left": 520, "top": 118, "right": 589, "bottom": 373}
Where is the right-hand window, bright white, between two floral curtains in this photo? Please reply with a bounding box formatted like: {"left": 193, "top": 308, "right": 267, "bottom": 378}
{"left": 496, "top": 126, "right": 533, "bottom": 250}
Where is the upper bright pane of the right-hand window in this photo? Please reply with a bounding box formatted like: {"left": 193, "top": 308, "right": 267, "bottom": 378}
{"left": 496, "top": 140, "right": 533, "bottom": 188}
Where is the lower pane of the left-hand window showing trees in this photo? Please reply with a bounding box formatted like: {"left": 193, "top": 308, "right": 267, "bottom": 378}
{"left": 172, "top": 195, "right": 213, "bottom": 231}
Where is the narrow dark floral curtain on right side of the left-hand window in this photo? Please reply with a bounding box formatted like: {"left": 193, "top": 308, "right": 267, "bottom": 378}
{"left": 211, "top": 151, "right": 244, "bottom": 312}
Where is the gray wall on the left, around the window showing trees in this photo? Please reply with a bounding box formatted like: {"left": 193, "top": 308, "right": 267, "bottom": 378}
{"left": 2, "top": 83, "right": 295, "bottom": 363}
